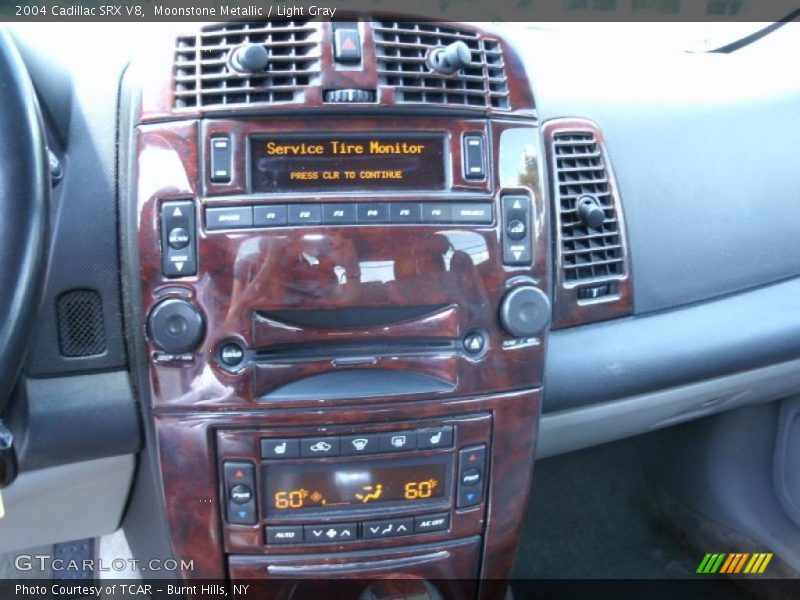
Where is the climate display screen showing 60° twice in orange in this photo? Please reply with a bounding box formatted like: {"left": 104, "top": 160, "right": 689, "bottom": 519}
{"left": 264, "top": 457, "right": 449, "bottom": 517}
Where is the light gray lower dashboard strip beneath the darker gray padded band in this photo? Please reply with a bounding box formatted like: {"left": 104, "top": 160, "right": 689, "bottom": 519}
{"left": 536, "top": 360, "right": 800, "bottom": 459}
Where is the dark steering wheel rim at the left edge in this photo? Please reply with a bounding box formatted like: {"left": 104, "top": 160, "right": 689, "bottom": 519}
{"left": 0, "top": 30, "right": 50, "bottom": 411}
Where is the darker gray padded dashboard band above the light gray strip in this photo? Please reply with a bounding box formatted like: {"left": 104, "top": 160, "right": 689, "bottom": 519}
{"left": 544, "top": 279, "right": 800, "bottom": 413}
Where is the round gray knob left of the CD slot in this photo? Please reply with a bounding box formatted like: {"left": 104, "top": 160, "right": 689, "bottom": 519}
{"left": 147, "top": 298, "right": 205, "bottom": 354}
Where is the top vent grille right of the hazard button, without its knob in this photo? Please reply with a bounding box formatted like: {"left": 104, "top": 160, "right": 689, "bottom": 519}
{"left": 373, "top": 21, "right": 509, "bottom": 110}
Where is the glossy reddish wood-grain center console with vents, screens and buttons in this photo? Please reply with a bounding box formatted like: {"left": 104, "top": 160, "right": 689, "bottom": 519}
{"left": 123, "top": 17, "right": 551, "bottom": 598}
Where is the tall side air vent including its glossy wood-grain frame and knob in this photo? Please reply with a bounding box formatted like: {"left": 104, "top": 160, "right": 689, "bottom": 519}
{"left": 544, "top": 119, "right": 632, "bottom": 326}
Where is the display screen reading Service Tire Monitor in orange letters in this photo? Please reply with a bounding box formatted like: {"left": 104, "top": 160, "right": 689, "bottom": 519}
{"left": 250, "top": 135, "right": 445, "bottom": 193}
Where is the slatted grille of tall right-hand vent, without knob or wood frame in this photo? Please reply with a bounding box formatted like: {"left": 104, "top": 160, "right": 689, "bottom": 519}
{"left": 552, "top": 131, "right": 625, "bottom": 284}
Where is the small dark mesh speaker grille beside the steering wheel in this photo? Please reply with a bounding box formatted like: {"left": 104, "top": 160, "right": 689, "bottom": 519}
{"left": 57, "top": 290, "right": 106, "bottom": 356}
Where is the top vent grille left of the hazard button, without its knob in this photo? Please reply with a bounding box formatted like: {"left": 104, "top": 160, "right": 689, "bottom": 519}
{"left": 174, "top": 21, "right": 320, "bottom": 108}
